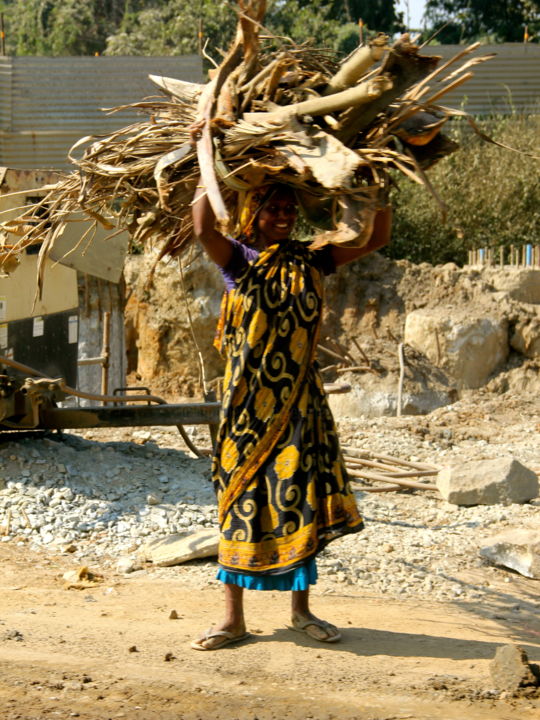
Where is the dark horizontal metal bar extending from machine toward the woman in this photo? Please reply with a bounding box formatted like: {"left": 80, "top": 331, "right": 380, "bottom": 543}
{"left": 37, "top": 402, "right": 221, "bottom": 429}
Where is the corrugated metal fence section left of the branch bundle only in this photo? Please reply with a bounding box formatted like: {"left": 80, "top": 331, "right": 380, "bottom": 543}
{"left": 0, "top": 55, "right": 204, "bottom": 169}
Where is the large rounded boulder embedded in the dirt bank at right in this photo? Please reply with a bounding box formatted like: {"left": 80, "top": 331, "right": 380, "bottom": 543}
{"left": 405, "top": 308, "right": 508, "bottom": 388}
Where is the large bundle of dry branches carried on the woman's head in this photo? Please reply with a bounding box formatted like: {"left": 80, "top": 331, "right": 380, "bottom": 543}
{"left": 0, "top": 0, "right": 498, "bottom": 284}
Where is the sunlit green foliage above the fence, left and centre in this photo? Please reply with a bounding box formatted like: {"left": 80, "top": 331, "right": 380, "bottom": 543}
{"left": 0, "top": 0, "right": 402, "bottom": 61}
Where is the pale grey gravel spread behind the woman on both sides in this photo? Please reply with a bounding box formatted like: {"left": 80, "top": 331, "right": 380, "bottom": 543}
{"left": 0, "top": 396, "right": 540, "bottom": 601}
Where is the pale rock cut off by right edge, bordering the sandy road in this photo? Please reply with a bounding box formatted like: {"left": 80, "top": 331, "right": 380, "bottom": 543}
{"left": 480, "top": 530, "right": 540, "bottom": 580}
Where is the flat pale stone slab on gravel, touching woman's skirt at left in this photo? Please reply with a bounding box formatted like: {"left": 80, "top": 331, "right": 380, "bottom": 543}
{"left": 139, "top": 529, "right": 219, "bottom": 567}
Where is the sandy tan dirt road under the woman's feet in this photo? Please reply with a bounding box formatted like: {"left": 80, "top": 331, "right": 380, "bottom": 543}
{"left": 0, "top": 543, "right": 540, "bottom": 720}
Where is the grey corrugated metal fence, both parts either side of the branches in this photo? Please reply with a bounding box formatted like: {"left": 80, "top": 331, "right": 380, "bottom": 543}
{"left": 0, "top": 44, "right": 540, "bottom": 169}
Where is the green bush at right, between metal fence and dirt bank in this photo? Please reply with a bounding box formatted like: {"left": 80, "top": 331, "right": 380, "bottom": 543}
{"left": 385, "top": 115, "right": 540, "bottom": 264}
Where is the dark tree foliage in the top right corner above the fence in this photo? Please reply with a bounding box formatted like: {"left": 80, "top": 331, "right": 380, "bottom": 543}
{"left": 425, "top": 0, "right": 540, "bottom": 43}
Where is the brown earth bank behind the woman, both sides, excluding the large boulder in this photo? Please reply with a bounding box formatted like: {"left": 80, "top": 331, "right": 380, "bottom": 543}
{"left": 126, "top": 253, "right": 540, "bottom": 415}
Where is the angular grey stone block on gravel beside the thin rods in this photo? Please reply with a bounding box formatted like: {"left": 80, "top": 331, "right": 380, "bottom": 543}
{"left": 437, "top": 457, "right": 538, "bottom": 505}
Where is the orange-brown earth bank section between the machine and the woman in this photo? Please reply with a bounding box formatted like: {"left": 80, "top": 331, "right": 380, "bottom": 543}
{"left": 125, "top": 254, "right": 224, "bottom": 400}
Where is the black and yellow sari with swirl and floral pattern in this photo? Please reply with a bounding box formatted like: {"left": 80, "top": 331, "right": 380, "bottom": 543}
{"left": 212, "top": 241, "right": 363, "bottom": 575}
